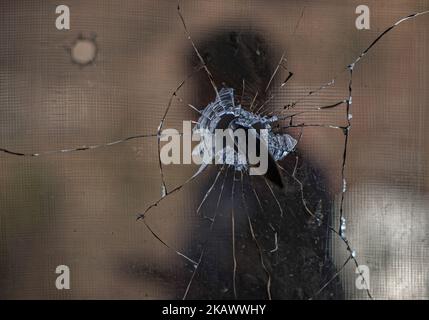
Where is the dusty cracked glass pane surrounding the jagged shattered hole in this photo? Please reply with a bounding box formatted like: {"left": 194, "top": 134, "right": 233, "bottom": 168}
{"left": 0, "top": 0, "right": 429, "bottom": 299}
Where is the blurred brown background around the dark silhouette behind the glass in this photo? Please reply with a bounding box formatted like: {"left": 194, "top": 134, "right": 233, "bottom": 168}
{"left": 0, "top": 0, "right": 429, "bottom": 299}
